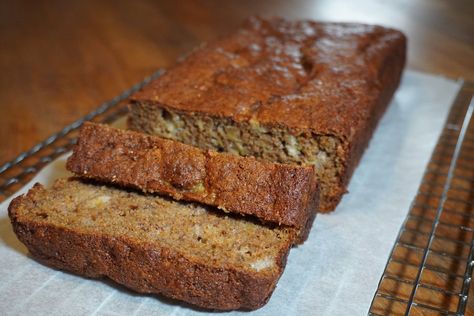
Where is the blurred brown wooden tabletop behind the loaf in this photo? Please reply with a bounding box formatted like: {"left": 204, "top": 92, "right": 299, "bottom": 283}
{"left": 0, "top": 0, "right": 474, "bottom": 164}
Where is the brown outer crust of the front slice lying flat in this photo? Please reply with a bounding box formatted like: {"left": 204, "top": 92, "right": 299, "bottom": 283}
{"left": 8, "top": 185, "right": 290, "bottom": 310}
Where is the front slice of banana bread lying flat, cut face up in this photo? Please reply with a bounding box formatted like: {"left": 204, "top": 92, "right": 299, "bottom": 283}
{"left": 9, "top": 179, "right": 295, "bottom": 310}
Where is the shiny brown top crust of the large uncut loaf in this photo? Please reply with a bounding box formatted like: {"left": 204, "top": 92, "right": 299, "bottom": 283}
{"left": 131, "top": 18, "right": 405, "bottom": 138}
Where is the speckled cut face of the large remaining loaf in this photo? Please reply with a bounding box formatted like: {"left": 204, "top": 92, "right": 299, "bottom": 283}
{"left": 128, "top": 102, "right": 345, "bottom": 212}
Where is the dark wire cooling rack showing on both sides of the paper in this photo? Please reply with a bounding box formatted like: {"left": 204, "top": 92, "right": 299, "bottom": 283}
{"left": 0, "top": 70, "right": 474, "bottom": 316}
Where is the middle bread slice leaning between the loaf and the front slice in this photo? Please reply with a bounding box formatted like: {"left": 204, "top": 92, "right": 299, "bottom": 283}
{"left": 67, "top": 123, "right": 318, "bottom": 229}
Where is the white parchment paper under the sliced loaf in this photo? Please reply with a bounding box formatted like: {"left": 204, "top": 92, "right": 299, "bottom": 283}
{"left": 0, "top": 71, "right": 461, "bottom": 315}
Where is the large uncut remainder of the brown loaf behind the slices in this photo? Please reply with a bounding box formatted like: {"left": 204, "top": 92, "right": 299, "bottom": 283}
{"left": 128, "top": 18, "right": 406, "bottom": 211}
